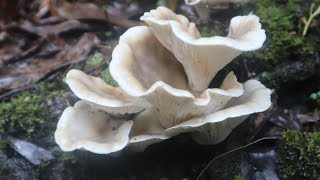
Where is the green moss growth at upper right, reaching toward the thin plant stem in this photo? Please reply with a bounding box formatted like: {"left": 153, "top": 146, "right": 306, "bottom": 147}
{"left": 245, "top": 0, "right": 315, "bottom": 69}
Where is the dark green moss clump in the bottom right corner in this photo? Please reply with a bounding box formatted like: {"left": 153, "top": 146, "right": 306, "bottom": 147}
{"left": 279, "top": 130, "right": 320, "bottom": 179}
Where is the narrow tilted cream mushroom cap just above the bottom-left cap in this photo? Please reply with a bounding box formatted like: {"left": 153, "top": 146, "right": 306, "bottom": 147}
{"left": 66, "top": 69, "right": 150, "bottom": 114}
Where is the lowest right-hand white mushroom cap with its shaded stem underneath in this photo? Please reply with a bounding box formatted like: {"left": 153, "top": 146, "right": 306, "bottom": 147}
{"left": 166, "top": 80, "right": 271, "bottom": 144}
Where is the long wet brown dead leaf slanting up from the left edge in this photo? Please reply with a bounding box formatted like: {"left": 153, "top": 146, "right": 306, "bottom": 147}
{"left": 0, "top": 33, "right": 100, "bottom": 92}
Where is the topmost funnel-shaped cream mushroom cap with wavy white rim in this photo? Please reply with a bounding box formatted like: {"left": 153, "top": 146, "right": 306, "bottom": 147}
{"left": 141, "top": 7, "right": 266, "bottom": 92}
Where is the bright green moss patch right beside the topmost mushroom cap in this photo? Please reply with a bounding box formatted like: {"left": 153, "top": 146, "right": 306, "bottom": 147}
{"left": 242, "top": 0, "right": 303, "bottom": 67}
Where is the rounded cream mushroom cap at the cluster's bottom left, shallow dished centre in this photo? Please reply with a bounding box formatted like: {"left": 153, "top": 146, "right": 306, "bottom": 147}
{"left": 54, "top": 101, "right": 132, "bottom": 154}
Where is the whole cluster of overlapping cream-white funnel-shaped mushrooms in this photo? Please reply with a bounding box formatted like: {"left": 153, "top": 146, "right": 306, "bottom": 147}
{"left": 55, "top": 7, "right": 271, "bottom": 154}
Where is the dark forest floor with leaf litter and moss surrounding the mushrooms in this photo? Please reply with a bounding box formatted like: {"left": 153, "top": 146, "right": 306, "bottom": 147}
{"left": 0, "top": 0, "right": 320, "bottom": 180}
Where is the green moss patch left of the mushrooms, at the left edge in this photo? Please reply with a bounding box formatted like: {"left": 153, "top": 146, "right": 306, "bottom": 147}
{"left": 0, "top": 83, "right": 62, "bottom": 135}
